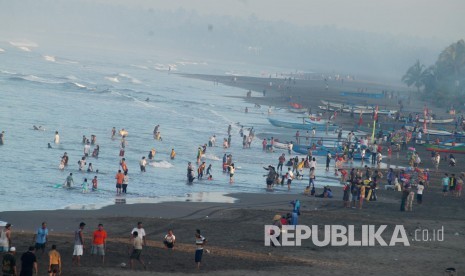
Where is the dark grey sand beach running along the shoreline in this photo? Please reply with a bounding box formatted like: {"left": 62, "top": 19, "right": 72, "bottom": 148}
{"left": 0, "top": 75, "right": 465, "bottom": 275}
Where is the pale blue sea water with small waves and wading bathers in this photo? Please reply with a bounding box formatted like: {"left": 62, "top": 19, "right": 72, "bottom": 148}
{"left": 0, "top": 43, "right": 338, "bottom": 211}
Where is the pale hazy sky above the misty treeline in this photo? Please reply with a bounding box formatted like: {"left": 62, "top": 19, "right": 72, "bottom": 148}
{"left": 98, "top": 0, "right": 465, "bottom": 41}
